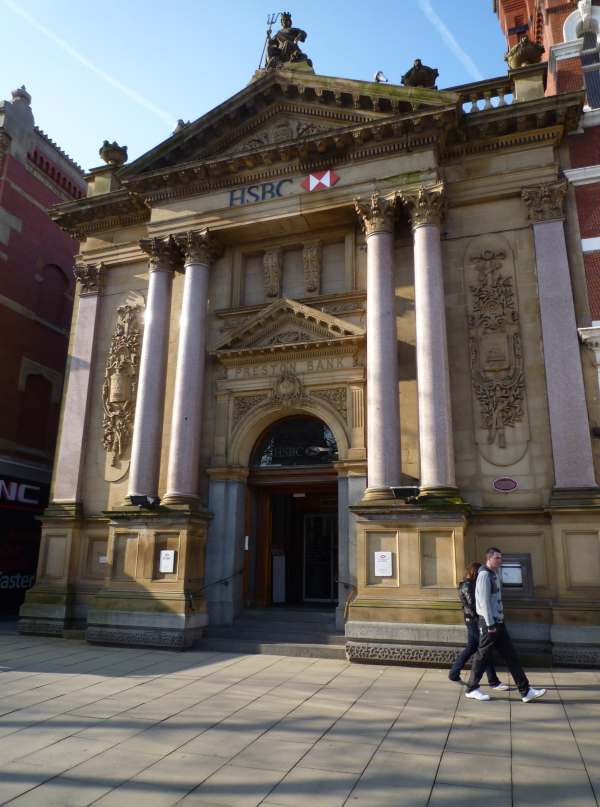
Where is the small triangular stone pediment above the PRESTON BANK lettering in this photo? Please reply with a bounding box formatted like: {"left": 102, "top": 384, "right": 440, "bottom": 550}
{"left": 216, "top": 297, "right": 365, "bottom": 357}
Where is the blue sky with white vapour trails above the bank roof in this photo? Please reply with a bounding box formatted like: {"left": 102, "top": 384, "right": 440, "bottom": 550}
{"left": 0, "top": 0, "right": 506, "bottom": 169}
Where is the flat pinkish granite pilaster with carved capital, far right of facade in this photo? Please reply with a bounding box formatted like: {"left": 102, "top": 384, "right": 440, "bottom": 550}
{"left": 522, "top": 182, "right": 596, "bottom": 490}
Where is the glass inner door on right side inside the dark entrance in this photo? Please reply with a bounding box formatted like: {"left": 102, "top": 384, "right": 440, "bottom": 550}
{"left": 303, "top": 513, "right": 338, "bottom": 602}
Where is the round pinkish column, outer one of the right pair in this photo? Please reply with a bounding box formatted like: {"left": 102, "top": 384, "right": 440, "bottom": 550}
{"left": 400, "top": 183, "right": 456, "bottom": 498}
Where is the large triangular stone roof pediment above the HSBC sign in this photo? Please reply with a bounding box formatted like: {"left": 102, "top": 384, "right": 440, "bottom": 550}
{"left": 119, "top": 69, "right": 459, "bottom": 184}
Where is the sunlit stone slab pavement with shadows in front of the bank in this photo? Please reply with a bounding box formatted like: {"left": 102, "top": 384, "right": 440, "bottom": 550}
{"left": 0, "top": 631, "right": 600, "bottom": 807}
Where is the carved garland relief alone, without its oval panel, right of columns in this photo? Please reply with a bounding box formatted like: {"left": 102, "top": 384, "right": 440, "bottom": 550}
{"left": 469, "top": 249, "right": 525, "bottom": 449}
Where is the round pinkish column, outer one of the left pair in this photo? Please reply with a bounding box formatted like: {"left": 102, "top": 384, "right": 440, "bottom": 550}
{"left": 128, "top": 237, "right": 180, "bottom": 499}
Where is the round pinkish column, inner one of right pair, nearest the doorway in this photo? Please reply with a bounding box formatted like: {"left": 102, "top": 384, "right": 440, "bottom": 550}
{"left": 355, "top": 193, "right": 400, "bottom": 501}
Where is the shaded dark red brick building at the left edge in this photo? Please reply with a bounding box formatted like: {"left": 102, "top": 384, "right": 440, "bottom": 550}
{"left": 0, "top": 87, "right": 85, "bottom": 613}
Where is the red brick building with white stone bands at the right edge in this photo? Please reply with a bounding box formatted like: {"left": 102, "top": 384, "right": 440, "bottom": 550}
{"left": 494, "top": 0, "right": 600, "bottom": 324}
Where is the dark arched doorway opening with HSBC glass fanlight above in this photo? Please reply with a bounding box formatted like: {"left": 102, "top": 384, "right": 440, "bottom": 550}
{"left": 244, "top": 415, "right": 338, "bottom": 607}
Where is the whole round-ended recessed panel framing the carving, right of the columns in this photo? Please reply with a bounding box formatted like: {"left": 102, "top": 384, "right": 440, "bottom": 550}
{"left": 465, "top": 235, "right": 530, "bottom": 466}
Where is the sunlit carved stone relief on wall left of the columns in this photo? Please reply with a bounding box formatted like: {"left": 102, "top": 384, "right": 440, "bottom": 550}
{"left": 102, "top": 303, "right": 142, "bottom": 467}
